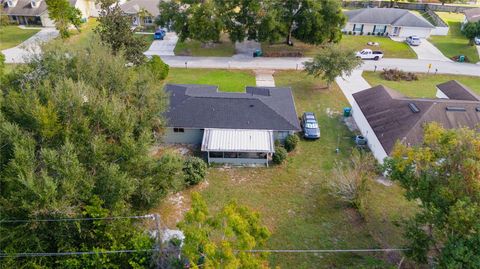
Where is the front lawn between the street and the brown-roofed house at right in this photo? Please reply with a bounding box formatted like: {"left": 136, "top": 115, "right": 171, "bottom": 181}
{"left": 363, "top": 72, "right": 480, "bottom": 98}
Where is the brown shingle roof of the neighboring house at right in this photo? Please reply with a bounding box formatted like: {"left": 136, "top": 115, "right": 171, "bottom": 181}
{"left": 353, "top": 85, "right": 480, "bottom": 154}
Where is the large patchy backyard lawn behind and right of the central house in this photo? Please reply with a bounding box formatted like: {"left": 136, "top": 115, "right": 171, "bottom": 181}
{"left": 154, "top": 70, "right": 411, "bottom": 268}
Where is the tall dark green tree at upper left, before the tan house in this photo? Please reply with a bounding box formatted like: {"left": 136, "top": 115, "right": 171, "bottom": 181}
{"left": 95, "top": 0, "right": 147, "bottom": 65}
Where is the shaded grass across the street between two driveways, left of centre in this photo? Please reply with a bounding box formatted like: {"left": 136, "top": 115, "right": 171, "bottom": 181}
{"left": 174, "top": 36, "right": 235, "bottom": 57}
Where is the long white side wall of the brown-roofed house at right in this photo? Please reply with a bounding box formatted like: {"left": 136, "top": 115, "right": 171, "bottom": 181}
{"left": 351, "top": 99, "right": 388, "bottom": 164}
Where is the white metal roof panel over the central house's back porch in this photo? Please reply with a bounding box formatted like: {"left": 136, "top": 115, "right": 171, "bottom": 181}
{"left": 202, "top": 129, "right": 275, "bottom": 152}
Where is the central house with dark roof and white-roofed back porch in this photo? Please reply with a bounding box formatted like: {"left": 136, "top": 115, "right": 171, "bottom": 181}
{"left": 164, "top": 84, "right": 300, "bottom": 165}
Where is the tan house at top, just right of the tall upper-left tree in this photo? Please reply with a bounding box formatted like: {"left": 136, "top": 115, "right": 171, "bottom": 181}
{"left": 120, "top": 0, "right": 160, "bottom": 26}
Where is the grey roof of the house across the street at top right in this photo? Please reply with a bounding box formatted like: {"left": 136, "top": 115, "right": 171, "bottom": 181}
{"left": 344, "top": 8, "right": 434, "bottom": 28}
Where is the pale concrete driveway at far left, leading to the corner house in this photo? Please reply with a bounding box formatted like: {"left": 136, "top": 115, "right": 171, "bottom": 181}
{"left": 2, "top": 28, "right": 58, "bottom": 63}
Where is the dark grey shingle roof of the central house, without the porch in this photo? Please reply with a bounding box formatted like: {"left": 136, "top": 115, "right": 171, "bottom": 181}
{"left": 165, "top": 84, "right": 300, "bottom": 131}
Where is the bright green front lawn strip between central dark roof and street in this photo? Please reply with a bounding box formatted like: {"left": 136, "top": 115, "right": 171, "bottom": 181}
{"left": 166, "top": 68, "right": 255, "bottom": 92}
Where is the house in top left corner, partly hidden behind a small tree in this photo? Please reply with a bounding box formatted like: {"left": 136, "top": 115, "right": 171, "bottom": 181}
{"left": 2, "top": 0, "right": 98, "bottom": 27}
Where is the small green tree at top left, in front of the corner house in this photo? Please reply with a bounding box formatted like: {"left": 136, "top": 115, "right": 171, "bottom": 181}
{"left": 45, "top": 0, "right": 82, "bottom": 38}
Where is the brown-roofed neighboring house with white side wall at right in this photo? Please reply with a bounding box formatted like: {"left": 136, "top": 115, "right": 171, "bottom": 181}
{"left": 352, "top": 80, "right": 480, "bottom": 163}
